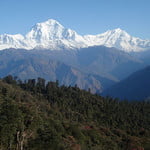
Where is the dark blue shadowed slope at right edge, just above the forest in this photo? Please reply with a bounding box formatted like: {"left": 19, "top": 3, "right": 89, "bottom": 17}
{"left": 103, "top": 66, "right": 150, "bottom": 100}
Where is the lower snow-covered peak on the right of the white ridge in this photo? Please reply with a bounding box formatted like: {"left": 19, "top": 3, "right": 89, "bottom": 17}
{"left": 84, "top": 28, "right": 150, "bottom": 52}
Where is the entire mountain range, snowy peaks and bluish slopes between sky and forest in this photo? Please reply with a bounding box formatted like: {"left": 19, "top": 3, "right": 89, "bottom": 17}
{"left": 0, "top": 19, "right": 150, "bottom": 99}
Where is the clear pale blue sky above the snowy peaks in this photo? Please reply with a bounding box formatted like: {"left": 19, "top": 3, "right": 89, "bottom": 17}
{"left": 0, "top": 0, "right": 150, "bottom": 39}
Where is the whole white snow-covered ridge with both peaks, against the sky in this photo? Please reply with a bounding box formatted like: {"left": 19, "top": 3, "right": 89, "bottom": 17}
{"left": 0, "top": 19, "right": 150, "bottom": 52}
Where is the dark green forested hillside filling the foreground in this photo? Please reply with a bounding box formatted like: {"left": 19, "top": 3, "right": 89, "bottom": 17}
{"left": 0, "top": 76, "right": 150, "bottom": 150}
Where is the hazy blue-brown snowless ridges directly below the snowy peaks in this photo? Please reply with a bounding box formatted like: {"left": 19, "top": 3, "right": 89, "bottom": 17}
{"left": 0, "top": 46, "right": 145, "bottom": 93}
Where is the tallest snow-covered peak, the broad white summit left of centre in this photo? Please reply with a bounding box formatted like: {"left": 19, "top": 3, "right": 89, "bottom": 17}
{"left": 25, "top": 19, "right": 84, "bottom": 49}
